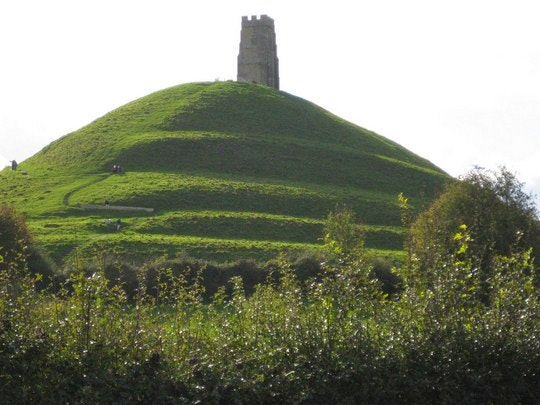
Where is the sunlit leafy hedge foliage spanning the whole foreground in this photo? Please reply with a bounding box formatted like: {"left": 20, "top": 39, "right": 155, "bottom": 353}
{"left": 0, "top": 228, "right": 540, "bottom": 403}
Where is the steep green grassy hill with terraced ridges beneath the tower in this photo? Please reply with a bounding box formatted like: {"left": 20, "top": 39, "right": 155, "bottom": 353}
{"left": 0, "top": 82, "right": 449, "bottom": 263}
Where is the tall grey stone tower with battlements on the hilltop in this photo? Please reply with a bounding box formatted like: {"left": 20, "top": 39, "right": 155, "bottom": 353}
{"left": 237, "top": 14, "right": 279, "bottom": 90}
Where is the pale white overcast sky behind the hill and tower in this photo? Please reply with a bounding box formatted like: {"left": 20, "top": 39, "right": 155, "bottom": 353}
{"left": 0, "top": 0, "right": 540, "bottom": 206}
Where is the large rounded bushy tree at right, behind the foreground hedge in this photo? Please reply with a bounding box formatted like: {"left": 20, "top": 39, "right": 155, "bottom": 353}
{"left": 409, "top": 168, "right": 540, "bottom": 281}
